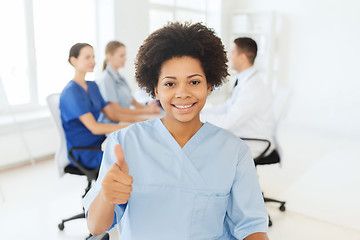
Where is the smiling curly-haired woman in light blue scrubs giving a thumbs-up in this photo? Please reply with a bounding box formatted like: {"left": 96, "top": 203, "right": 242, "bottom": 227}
{"left": 84, "top": 22, "right": 268, "bottom": 240}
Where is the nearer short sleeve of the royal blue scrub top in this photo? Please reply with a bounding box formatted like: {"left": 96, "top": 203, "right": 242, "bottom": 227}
{"left": 60, "top": 85, "right": 91, "bottom": 121}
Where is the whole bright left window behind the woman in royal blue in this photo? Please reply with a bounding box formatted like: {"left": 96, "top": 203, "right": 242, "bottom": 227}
{"left": 0, "top": 0, "right": 99, "bottom": 110}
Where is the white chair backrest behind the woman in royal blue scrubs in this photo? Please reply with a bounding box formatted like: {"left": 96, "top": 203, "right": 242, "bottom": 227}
{"left": 46, "top": 93, "right": 70, "bottom": 176}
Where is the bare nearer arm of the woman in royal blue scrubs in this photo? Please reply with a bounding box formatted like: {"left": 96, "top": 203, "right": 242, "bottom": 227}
{"left": 79, "top": 112, "right": 128, "bottom": 135}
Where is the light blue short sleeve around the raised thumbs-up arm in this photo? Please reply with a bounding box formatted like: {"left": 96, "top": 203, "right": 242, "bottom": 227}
{"left": 83, "top": 132, "right": 127, "bottom": 222}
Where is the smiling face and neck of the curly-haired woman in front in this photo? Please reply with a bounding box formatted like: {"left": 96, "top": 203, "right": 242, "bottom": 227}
{"left": 155, "top": 56, "right": 211, "bottom": 126}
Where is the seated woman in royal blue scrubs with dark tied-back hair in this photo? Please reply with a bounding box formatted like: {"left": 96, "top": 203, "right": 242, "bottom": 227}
{"left": 59, "top": 43, "right": 137, "bottom": 169}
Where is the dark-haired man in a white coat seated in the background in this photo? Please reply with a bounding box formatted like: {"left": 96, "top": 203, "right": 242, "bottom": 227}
{"left": 200, "top": 37, "right": 275, "bottom": 158}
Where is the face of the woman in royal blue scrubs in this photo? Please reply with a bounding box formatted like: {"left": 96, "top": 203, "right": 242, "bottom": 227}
{"left": 71, "top": 46, "right": 95, "bottom": 73}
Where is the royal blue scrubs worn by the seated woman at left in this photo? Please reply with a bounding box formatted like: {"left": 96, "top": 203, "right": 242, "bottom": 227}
{"left": 59, "top": 80, "right": 107, "bottom": 169}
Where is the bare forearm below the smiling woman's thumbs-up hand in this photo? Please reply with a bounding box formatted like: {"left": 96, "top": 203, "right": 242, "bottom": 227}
{"left": 87, "top": 192, "right": 115, "bottom": 236}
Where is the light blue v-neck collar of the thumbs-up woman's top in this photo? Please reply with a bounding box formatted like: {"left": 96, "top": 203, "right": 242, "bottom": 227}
{"left": 155, "top": 118, "right": 209, "bottom": 152}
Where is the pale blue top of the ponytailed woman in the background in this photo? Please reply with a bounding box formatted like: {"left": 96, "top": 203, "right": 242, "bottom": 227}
{"left": 96, "top": 65, "right": 133, "bottom": 123}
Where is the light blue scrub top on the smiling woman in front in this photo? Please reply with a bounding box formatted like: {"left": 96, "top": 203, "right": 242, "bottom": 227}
{"left": 83, "top": 119, "right": 268, "bottom": 240}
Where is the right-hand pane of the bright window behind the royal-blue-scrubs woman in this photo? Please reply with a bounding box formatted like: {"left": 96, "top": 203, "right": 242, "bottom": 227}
{"left": 33, "top": 0, "right": 96, "bottom": 104}
